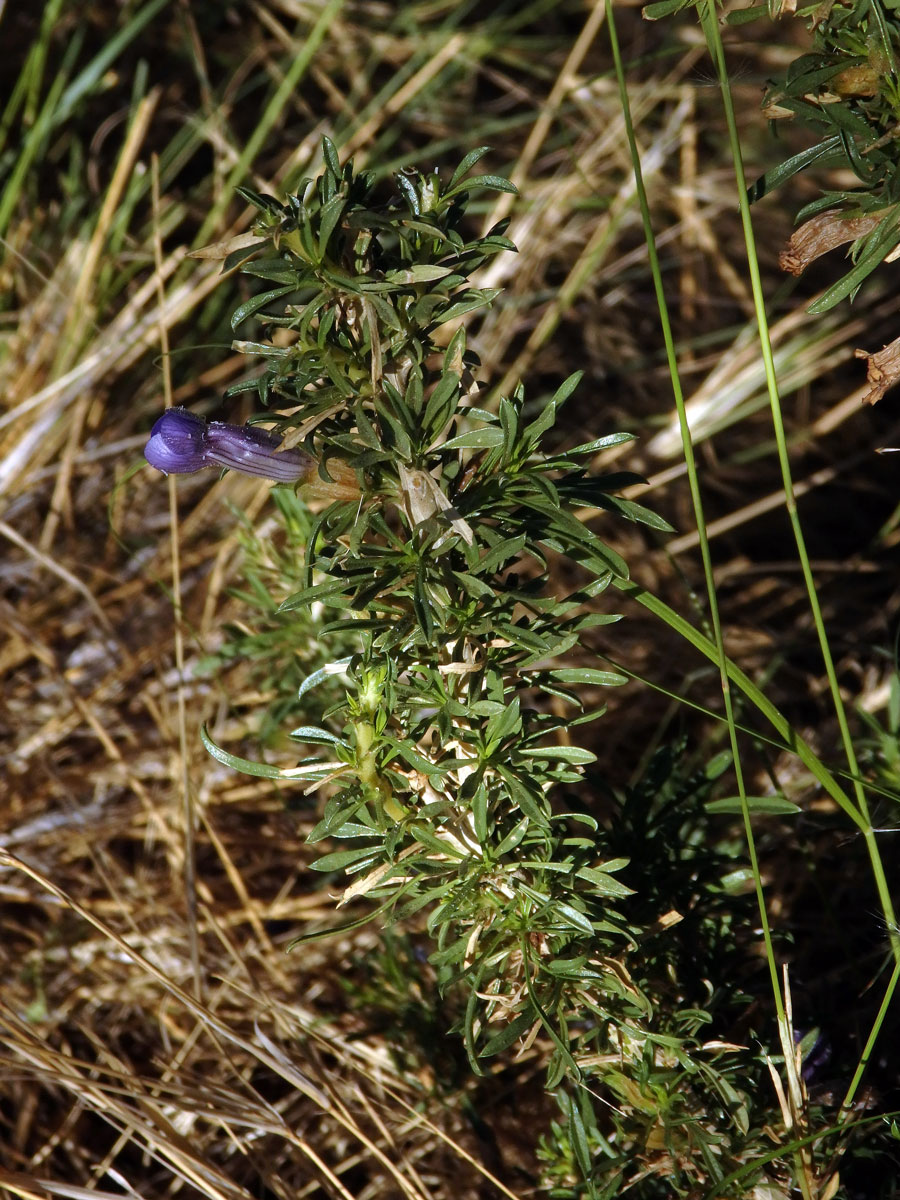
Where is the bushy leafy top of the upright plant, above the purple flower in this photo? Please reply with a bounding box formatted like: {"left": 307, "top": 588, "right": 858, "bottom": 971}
{"left": 224, "top": 138, "right": 515, "bottom": 424}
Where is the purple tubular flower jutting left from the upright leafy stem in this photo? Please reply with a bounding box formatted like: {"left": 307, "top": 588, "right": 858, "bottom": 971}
{"left": 144, "top": 408, "right": 316, "bottom": 484}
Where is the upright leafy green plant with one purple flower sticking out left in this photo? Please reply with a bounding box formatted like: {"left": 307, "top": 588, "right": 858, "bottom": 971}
{"left": 148, "top": 140, "right": 777, "bottom": 1190}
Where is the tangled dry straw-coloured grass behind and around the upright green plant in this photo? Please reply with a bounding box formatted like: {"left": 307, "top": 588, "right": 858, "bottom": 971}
{"left": 0, "top": 0, "right": 898, "bottom": 1200}
